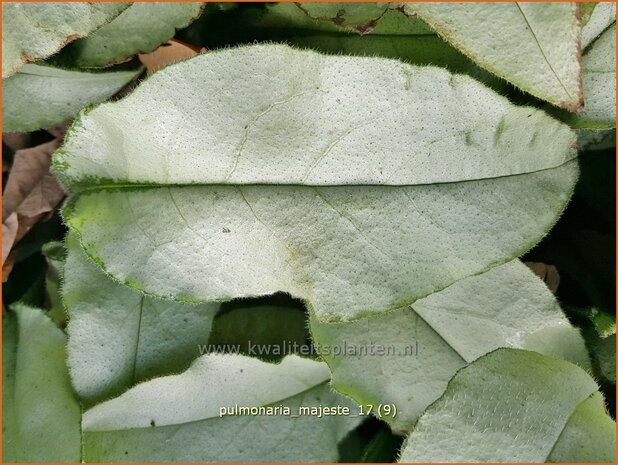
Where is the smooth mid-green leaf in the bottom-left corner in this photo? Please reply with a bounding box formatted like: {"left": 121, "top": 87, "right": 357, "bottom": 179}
{"left": 2, "top": 306, "right": 81, "bottom": 463}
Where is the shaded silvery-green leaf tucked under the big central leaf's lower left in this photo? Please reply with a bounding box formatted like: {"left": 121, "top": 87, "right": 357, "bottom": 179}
{"left": 62, "top": 234, "right": 219, "bottom": 403}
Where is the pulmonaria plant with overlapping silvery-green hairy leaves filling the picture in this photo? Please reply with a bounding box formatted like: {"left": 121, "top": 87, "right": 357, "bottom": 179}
{"left": 3, "top": 2, "right": 615, "bottom": 462}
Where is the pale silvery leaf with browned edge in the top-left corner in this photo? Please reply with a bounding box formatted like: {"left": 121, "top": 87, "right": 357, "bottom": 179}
{"left": 2, "top": 2, "right": 130, "bottom": 79}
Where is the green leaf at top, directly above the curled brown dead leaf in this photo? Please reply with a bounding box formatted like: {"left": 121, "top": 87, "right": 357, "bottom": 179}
{"left": 56, "top": 2, "right": 203, "bottom": 68}
